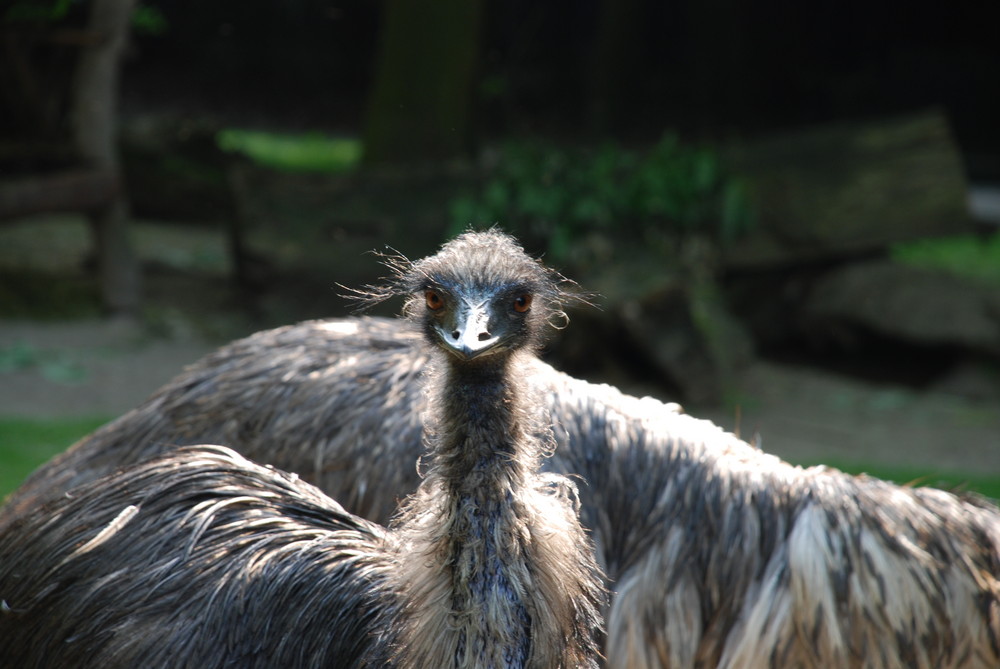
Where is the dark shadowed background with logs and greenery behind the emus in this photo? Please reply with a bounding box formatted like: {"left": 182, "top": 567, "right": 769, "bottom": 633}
{"left": 0, "top": 0, "right": 1000, "bottom": 495}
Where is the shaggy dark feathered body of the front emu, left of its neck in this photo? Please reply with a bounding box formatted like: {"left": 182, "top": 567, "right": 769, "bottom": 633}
{"left": 0, "top": 446, "right": 396, "bottom": 669}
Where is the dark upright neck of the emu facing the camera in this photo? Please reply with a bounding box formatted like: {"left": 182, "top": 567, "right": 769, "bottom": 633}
{"left": 426, "top": 358, "right": 538, "bottom": 668}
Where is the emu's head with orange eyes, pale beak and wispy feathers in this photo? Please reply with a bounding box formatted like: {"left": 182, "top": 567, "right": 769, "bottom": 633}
{"left": 369, "top": 230, "right": 570, "bottom": 361}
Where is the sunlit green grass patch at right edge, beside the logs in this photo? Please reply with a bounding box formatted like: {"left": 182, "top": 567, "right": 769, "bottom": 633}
{"left": 891, "top": 232, "right": 1000, "bottom": 285}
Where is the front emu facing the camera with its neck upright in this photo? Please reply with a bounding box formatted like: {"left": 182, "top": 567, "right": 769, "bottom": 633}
{"left": 0, "top": 231, "right": 604, "bottom": 669}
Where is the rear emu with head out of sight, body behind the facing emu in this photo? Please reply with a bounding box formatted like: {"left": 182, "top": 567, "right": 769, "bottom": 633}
{"left": 0, "top": 272, "right": 1000, "bottom": 669}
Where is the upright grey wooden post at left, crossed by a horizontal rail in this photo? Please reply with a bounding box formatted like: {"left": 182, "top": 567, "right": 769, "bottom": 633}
{"left": 71, "top": 0, "right": 139, "bottom": 313}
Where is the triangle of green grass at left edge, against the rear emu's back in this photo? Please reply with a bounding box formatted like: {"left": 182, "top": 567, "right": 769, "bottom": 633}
{"left": 0, "top": 418, "right": 107, "bottom": 500}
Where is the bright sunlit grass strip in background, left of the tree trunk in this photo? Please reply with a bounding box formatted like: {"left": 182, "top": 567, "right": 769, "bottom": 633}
{"left": 216, "top": 128, "right": 361, "bottom": 172}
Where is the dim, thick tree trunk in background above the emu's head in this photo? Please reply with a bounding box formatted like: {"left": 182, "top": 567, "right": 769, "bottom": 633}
{"left": 364, "top": 0, "right": 483, "bottom": 164}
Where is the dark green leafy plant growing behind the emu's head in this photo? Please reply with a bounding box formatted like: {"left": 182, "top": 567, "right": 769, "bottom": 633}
{"left": 451, "top": 135, "right": 754, "bottom": 259}
